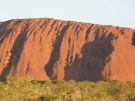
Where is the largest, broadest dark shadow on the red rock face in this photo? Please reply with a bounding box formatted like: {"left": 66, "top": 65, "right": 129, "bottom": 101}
{"left": 64, "top": 33, "right": 116, "bottom": 81}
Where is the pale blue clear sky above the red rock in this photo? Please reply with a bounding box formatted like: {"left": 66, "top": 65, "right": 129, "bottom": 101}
{"left": 0, "top": 0, "right": 135, "bottom": 28}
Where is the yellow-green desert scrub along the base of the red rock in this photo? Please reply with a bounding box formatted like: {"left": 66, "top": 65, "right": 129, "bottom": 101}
{"left": 0, "top": 76, "right": 135, "bottom": 101}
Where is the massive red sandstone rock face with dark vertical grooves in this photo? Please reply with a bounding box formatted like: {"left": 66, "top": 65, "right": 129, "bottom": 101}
{"left": 0, "top": 19, "right": 135, "bottom": 81}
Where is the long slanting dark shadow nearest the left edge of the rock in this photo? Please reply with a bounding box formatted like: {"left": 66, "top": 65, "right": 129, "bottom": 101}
{"left": 0, "top": 25, "right": 28, "bottom": 80}
